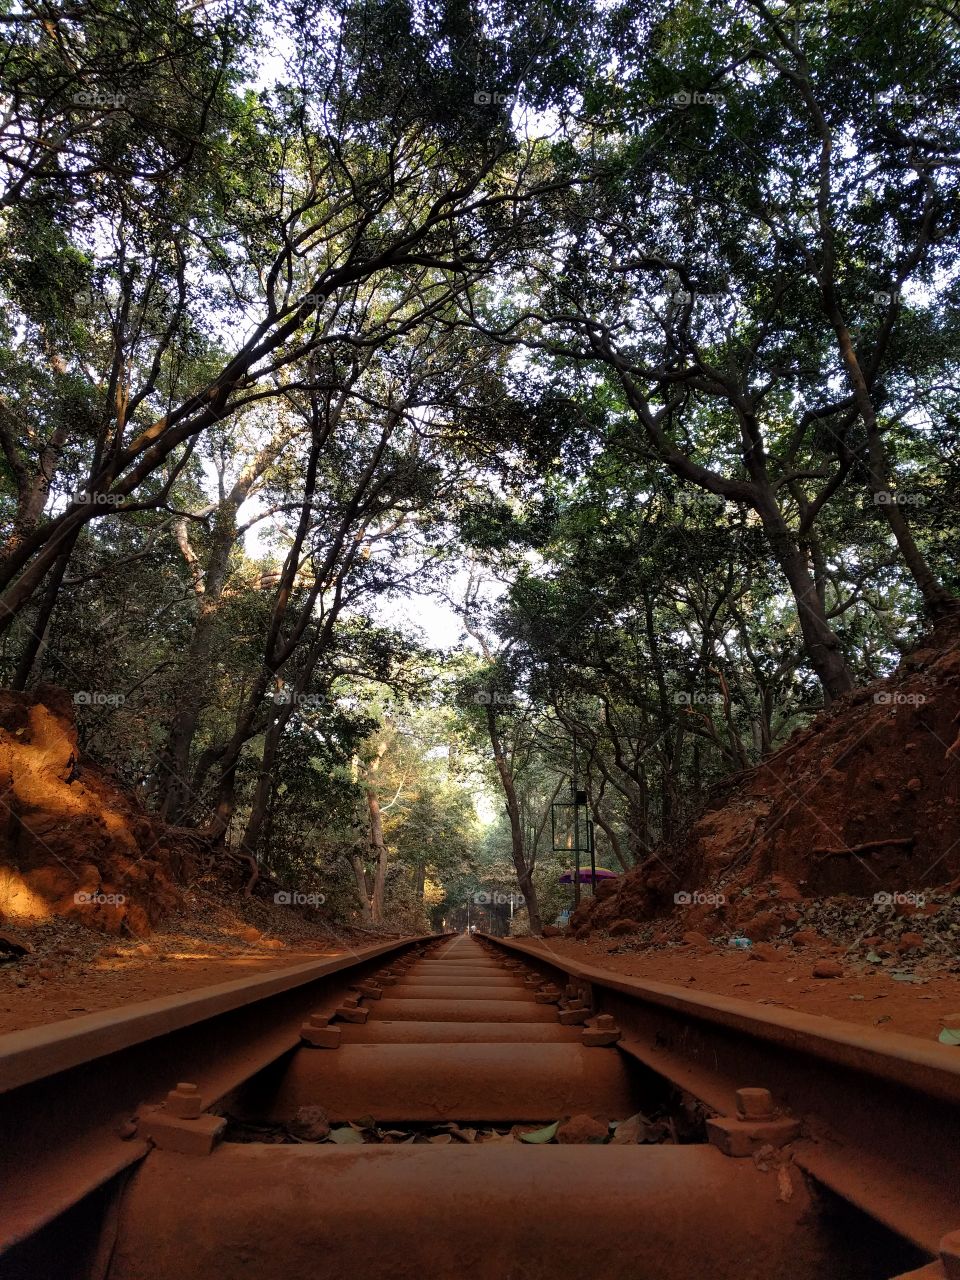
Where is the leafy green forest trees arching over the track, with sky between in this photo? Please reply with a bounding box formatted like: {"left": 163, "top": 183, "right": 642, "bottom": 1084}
{"left": 0, "top": 0, "right": 960, "bottom": 932}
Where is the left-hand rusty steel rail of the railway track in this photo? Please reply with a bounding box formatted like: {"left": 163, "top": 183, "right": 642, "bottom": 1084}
{"left": 0, "top": 937, "right": 426, "bottom": 1257}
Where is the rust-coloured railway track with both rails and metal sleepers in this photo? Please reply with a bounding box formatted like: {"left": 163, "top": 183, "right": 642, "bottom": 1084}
{"left": 0, "top": 936, "right": 960, "bottom": 1280}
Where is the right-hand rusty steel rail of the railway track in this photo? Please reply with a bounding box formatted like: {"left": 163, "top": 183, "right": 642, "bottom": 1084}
{"left": 484, "top": 934, "right": 960, "bottom": 1256}
